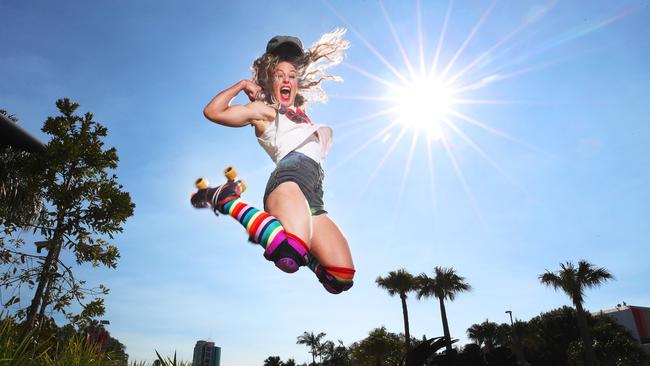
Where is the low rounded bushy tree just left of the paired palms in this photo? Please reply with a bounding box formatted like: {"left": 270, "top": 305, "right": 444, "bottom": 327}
{"left": 350, "top": 327, "right": 404, "bottom": 366}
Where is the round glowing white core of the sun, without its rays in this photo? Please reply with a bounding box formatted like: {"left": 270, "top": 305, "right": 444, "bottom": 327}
{"left": 395, "top": 78, "right": 451, "bottom": 140}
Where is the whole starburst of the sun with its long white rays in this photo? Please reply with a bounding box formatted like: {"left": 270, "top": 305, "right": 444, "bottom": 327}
{"left": 324, "top": 0, "right": 631, "bottom": 224}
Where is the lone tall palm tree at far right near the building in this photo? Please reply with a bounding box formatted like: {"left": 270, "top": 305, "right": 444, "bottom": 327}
{"left": 539, "top": 260, "right": 614, "bottom": 366}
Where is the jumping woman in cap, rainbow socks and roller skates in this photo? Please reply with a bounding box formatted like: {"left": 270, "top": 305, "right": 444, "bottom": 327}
{"left": 191, "top": 30, "right": 355, "bottom": 294}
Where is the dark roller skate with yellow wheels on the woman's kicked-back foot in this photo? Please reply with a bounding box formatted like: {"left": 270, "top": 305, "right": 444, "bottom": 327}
{"left": 190, "top": 166, "right": 246, "bottom": 215}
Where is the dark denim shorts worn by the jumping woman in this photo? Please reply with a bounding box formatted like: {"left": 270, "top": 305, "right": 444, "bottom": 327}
{"left": 264, "top": 151, "right": 327, "bottom": 216}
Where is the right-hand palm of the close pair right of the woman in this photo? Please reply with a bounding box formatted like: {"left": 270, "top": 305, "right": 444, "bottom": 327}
{"left": 416, "top": 266, "right": 472, "bottom": 353}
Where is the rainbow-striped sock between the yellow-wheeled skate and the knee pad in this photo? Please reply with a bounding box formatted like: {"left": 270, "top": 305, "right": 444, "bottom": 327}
{"left": 223, "top": 199, "right": 285, "bottom": 249}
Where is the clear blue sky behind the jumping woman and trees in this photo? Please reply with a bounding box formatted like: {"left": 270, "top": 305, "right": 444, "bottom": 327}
{"left": 0, "top": 0, "right": 650, "bottom": 365}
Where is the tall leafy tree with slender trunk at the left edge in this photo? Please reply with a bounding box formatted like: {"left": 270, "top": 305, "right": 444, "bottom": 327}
{"left": 0, "top": 99, "right": 135, "bottom": 327}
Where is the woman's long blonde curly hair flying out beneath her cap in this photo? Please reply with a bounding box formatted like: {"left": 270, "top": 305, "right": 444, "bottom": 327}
{"left": 252, "top": 28, "right": 350, "bottom": 108}
